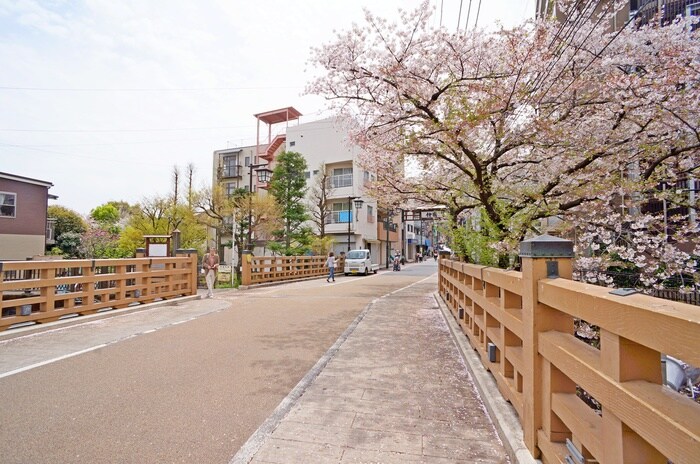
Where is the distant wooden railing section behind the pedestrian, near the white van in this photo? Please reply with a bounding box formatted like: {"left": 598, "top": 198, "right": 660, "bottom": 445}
{"left": 241, "top": 255, "right": 345, "bottom": 285}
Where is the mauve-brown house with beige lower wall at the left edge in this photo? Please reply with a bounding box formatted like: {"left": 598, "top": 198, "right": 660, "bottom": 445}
{"left": 0, "top": 172, "right": 57, "bottom": 261}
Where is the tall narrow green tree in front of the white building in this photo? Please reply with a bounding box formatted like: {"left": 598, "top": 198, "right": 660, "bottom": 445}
{"left": 268, "top": 151, "right": 312, "bottom": 256}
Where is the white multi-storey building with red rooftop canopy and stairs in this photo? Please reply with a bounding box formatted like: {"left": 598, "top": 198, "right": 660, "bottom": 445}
{"left": 213, "top": 111, "right": 403, "bottom": 264}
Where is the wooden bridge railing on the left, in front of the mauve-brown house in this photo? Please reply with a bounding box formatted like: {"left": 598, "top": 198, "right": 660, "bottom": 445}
{"left": 0, "top": 253, "right": 197, "bottom": 330}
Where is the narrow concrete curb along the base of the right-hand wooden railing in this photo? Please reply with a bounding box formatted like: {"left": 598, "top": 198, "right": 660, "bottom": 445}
{"left": 433, "top": 292, "right": 541, "bottom": 464}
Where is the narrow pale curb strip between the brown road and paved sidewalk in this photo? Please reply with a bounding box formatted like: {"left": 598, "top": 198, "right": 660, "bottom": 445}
{"left": 229, "top": 299, "right": 377, "bottom": 464}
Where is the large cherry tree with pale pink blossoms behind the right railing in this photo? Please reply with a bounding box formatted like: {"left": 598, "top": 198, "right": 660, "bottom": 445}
{"left": 307, "top": 2, "right": 700, "bottom": 290}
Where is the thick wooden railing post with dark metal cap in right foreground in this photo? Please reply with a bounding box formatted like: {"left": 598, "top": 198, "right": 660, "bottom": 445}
{"left": 520, "top": 235, "right": 573, "bottom": 457}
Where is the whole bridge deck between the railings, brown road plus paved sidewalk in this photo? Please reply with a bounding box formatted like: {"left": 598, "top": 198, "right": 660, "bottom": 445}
{"left": 0, "top": 262, "right": 508, "bottom": 463}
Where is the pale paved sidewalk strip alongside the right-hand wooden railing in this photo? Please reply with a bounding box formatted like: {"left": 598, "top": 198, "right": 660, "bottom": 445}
{"left": 232, "top": 276, "right": 510, "bottom": 464}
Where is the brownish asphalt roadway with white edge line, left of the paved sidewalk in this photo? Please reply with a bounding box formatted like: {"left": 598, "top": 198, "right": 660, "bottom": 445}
{"left": 0, "top": 260, "right": 437, "bottom": 463}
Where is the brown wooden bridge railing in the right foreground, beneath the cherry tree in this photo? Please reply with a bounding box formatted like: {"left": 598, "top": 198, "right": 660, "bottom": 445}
{"left": 439, "top": 237, "right": 700, "bottom": 464}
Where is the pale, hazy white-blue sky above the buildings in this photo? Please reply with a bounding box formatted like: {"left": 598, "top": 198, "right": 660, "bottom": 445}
{"left": 0, "top": 0, "right": 535, "bottom": 214}
